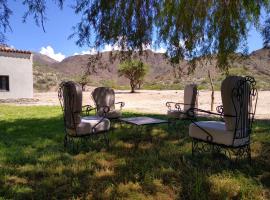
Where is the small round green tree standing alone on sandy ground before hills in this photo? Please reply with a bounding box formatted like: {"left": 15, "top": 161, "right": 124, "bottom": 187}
{"left": 118, "top": 60, "right": 148, "bottom": 93}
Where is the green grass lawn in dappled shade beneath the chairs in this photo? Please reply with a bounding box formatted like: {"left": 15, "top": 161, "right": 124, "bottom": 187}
{"left": 0, "top": 105, "right": 270, "bottom": 199}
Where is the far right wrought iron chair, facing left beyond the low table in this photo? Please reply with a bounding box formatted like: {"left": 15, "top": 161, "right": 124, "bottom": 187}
{"left": 166, "top": 84, "right": 198, "bottom": 123}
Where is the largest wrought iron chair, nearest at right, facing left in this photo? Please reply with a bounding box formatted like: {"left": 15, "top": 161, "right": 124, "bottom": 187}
{"left": 188, "top": 76, "right": 258, "bottom": 163}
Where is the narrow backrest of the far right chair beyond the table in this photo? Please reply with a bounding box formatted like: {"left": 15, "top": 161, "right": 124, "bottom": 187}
{"left": 184, "top": 84, "right": 198, "bottom": 111}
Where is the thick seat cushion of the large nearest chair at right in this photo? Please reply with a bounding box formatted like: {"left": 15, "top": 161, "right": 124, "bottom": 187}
{"left": 189, "top": 121, "right": 249, "bottom": 146}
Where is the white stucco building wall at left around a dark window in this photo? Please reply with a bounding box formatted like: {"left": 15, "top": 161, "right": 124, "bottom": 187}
{"left": 0, "top": 52, "right": 33, "bottom": 99}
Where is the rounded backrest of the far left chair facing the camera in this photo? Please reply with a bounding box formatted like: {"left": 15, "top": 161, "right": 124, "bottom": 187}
{"left": 92, "top": 87, "right": 115, "bottom": 111}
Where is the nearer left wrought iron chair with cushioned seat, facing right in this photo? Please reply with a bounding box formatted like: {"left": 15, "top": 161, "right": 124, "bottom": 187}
{"left": 58, "top": 81, "right": 110, "bottom": 149}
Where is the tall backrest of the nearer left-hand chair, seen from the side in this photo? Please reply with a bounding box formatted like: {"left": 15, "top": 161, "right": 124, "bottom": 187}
{"left": 58, "top": 81, "right": 82, "bottom": 129}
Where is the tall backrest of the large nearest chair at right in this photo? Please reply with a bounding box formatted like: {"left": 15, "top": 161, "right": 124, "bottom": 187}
{"left": 221, "top": 76, "right": 258, "bottom": 139}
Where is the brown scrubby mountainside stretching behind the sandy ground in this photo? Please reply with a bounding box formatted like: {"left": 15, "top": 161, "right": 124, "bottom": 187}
{"left": 34, "top": 49, "right": 270, "bottom": 91}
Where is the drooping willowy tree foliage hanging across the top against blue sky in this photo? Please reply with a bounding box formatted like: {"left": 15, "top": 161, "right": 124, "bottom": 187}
{"left": 0, "top": 0, "right": 270, "bottom": 71}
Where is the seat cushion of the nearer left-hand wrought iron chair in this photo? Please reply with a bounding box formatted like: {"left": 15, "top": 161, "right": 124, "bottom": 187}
{"left": 67, "top": 116, "right": 110, "bottom": 136}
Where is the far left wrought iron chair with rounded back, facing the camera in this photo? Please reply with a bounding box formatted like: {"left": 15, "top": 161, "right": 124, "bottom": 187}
{"left": 92, "top": 87, "right": 125, "bottom": 120}
